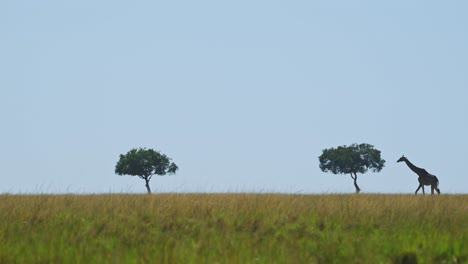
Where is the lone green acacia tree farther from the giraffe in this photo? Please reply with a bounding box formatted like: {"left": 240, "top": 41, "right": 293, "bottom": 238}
{"left": 115, "top": 148, "right": 179, "bottom": 193}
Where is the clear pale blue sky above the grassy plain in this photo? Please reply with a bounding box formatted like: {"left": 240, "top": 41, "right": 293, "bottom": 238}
{"left": 0, "top": 0, "right": 468, "bottom": 193}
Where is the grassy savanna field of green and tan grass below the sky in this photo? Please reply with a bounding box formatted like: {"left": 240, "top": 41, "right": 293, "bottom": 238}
{"left": 0, "top": 194, "right": 468, "bottom": 263}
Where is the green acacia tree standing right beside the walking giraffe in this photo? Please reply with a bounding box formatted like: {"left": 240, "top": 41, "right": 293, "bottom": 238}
{"left": 319, "top": 144, "right": 385, "bottom": 193}
